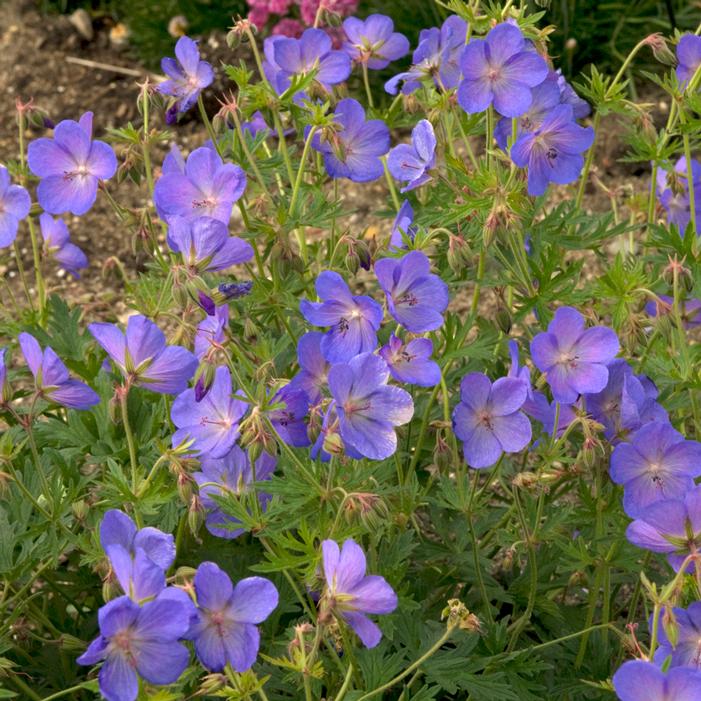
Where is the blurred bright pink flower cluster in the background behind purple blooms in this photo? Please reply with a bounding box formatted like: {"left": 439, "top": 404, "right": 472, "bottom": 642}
{"left": 248, "top": 0, "right": 359, "bottom": 37}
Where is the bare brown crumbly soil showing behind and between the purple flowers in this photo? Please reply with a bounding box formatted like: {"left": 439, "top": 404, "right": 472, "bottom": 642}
{"left": 0, "top": 0, "right": 664, "bottom": 317}
